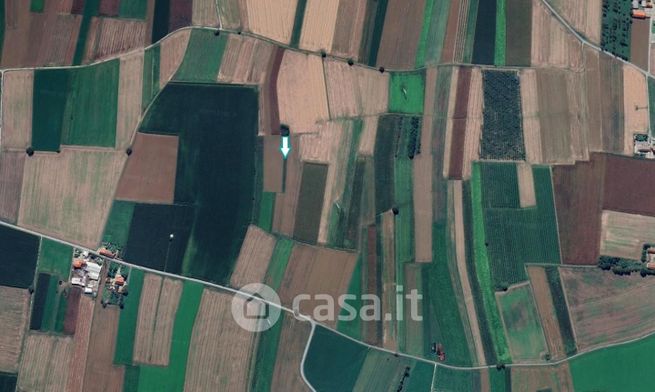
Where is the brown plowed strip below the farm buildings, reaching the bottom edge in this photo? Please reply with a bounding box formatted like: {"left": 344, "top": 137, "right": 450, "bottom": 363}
{"left": 82, "top": 306, "right": 125, "bottom": 392}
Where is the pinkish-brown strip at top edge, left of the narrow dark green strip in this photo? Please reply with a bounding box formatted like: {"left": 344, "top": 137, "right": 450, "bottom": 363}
{"left": 332, "top": 0, "right": 367, "bottom": 60}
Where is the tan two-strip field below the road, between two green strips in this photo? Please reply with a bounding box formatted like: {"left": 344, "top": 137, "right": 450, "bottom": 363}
{"left": 133, "top": 274, "right": 182, "bottom": 366}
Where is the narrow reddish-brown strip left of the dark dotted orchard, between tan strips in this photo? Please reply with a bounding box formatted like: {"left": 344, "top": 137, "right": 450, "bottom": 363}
{"left": 448, "top": 68, "right": 471, "bottom": 180}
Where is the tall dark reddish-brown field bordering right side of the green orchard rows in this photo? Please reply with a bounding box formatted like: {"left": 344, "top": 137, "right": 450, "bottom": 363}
{"left": 553, "top": 154, "right": 608, "bottom": 265}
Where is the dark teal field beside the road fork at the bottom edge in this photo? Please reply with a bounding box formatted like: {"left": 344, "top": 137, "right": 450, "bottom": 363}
{"left": 305, "top": 326, "right": 369, "bottom": 391}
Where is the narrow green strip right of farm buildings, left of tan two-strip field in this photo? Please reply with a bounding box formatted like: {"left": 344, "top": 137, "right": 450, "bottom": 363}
{"left": 114, "top": 268, "right": 144, "bottom": 365}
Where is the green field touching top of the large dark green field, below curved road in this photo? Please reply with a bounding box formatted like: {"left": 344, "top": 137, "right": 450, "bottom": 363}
{"left": 173, "top": 29, "right": 227, "bottom": 83}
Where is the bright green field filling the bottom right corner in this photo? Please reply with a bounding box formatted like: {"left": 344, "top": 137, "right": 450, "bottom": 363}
{"left": 570, "top": 335, "right": 655, "bottom": 392}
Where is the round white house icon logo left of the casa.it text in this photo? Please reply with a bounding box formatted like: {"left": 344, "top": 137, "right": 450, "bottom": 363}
{"left": 232, "top": 283, "right": 281, "bottom": 332}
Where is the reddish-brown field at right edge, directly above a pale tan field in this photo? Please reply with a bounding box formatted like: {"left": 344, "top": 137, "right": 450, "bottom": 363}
{"left": 603, "top": 155, "right": 655, "bottom": 216}
